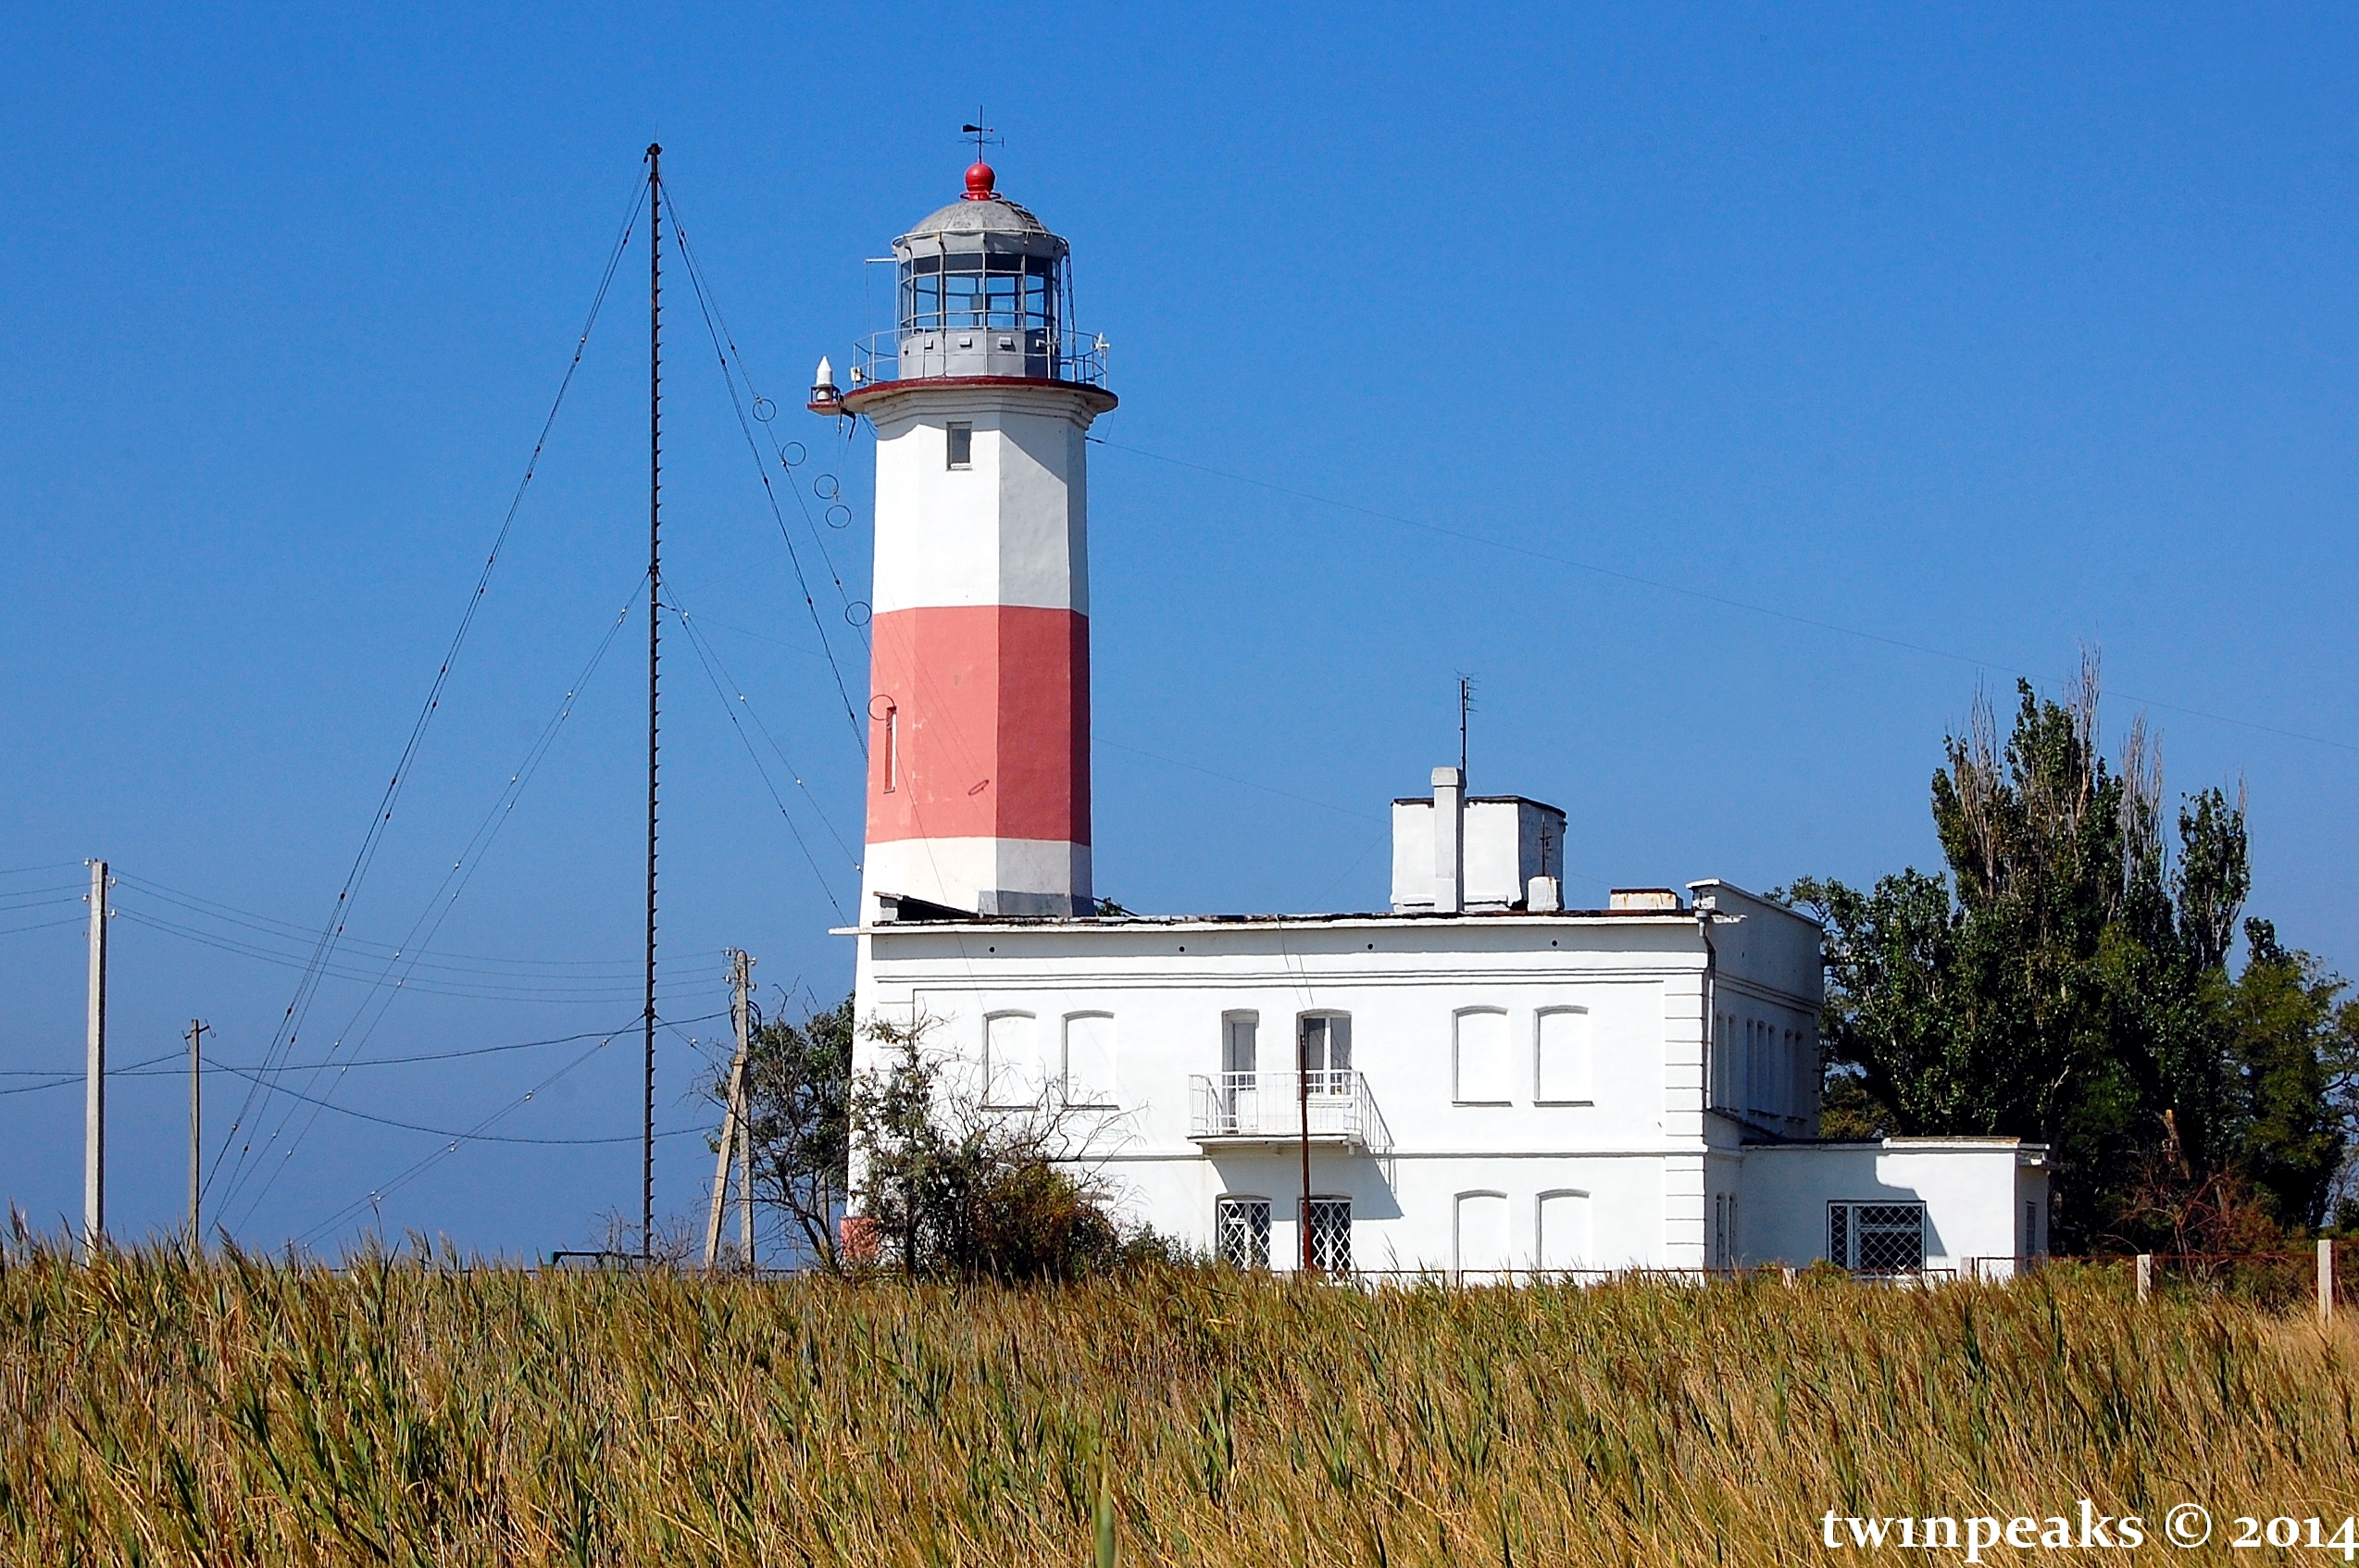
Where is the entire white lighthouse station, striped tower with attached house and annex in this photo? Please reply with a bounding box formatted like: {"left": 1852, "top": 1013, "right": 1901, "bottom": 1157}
{"left": 812, "top": 165, "right": 2048, "bottom": 1278}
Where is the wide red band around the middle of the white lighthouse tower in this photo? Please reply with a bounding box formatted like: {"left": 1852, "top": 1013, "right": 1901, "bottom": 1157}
{"left": 868, "top": 604, "right": 1090, "bottom": 844}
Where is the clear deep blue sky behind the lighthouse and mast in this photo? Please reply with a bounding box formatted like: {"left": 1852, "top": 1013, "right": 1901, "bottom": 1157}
{"left": 0, "top": 5, "right": 2359, "bottom": 1252}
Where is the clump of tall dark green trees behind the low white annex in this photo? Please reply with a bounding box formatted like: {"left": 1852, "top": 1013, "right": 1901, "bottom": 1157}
{"left": 1786, "top": 660, "right": 2350, "bottom": 1248}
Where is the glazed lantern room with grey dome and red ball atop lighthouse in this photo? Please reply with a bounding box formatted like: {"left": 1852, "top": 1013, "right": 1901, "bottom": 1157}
{"left": 854, "top": 163, "right": 1104, "bottom": 387}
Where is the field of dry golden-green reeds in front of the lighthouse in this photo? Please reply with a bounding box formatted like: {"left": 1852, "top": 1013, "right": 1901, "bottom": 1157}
{"left": 0, "top": 1242, "right": 2359, "bottom": 1568}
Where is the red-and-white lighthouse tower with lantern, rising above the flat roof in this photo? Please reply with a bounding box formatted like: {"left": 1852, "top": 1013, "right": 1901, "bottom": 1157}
{"left": 812, "top": 163, "right": 1116, "bottom": 925}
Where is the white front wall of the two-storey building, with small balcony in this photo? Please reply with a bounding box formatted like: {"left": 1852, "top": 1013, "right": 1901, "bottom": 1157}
{"left": 858, "top": 913, "right": 1754, "bottom": 1268}
